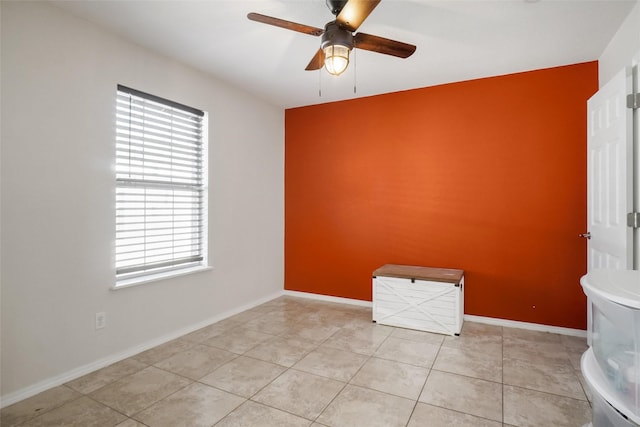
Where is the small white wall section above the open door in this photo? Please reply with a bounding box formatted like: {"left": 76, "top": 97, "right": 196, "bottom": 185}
{"left": 598, "top": 1, "right": 640, "bottom": 87}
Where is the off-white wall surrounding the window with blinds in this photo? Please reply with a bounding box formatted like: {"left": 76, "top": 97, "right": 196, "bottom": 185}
{"left": 0, "top": 1, "right": 284, "bottom": 405}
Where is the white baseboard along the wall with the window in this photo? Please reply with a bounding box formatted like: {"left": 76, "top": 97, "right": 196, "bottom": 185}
{"left": 0, "top": 291, "right": 282, "bottom": 408}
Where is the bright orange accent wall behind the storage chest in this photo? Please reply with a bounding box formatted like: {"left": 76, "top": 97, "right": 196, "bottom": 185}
{"left": 285, "top": 62, "right": 598, "bottom": 329}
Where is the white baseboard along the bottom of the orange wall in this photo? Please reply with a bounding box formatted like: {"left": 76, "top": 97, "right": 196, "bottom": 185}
{"left": 282, "top": 290, "right": 587, "bottom": 337}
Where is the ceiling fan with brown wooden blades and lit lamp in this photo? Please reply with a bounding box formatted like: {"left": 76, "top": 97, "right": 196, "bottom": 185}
{"left": 247, "top": 0, "right": 416, "bottom": 76}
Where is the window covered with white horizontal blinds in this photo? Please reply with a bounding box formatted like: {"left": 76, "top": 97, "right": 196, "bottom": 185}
{"left": 115, "top": 85, "right": 206, "bottom": 285}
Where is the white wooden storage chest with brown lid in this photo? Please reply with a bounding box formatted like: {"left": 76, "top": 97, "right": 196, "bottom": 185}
{"left": 373, "top": 264, "right": 464, "bottom": 335}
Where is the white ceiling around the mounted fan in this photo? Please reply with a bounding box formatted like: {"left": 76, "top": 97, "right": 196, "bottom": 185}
{"left": 54, "top": 0, "right": 637, "bottom": 108}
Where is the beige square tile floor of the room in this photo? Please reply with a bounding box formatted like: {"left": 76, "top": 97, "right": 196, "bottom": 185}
{"left": 0, "top": 297, "right": 591, "bottom": 427}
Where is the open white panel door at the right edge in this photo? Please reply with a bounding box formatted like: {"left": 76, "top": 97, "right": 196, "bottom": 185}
{"left": 587, "top": 68, "right": 633, "bottom": 271}
